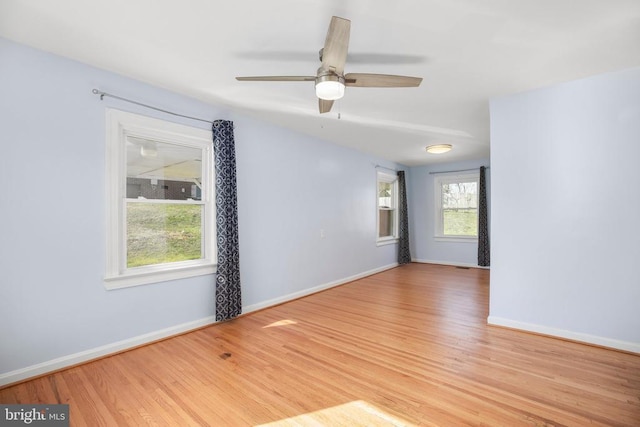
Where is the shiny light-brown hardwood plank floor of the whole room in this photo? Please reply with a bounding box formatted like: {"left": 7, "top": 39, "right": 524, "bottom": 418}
{"left": 0, "top": 264, "right": 640, "bottom": 426}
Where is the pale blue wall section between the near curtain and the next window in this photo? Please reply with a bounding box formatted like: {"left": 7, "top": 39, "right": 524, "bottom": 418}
{"left": 235, "top": 118, "right": 397, "bottom": 306}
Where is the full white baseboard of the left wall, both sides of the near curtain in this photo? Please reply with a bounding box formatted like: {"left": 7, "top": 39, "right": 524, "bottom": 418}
{"left": 0, "top": 263, "right": 398, "bottom": 387}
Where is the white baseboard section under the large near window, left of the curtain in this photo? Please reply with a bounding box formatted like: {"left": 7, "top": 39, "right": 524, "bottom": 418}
{"left": 0, "top": 316, "right": 216, "bottom": 386}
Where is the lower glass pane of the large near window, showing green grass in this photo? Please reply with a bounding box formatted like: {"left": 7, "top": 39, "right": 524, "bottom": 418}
{"left": 127, "top": 202, "right": 204, "bottom": 267}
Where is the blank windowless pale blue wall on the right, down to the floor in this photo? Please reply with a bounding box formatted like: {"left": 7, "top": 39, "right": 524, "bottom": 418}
{"left": 489, "top": 68, "right": 640, "bottom": 352}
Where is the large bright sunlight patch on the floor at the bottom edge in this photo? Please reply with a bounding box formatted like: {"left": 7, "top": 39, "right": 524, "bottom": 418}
{"left": 256, "top": 400, "right": 414, "bottom": 427}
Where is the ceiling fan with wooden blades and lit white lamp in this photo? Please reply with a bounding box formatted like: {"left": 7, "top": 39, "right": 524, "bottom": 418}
{"left": 236, "top": 16, "right": 422, "bottom": 113}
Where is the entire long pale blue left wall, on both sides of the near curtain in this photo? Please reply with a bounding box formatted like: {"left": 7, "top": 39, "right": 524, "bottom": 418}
{"left": 0, "top": 39, "right": 396, "bottom": 379}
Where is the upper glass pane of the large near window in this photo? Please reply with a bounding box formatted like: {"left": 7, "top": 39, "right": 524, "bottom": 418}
{"left": 127, "top": 136, "right": 202, "bottom": 200}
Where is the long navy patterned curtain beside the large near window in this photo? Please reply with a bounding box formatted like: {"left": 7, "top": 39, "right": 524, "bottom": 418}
{"left": 212, "top": 120, "right": 242, "bottom": 321}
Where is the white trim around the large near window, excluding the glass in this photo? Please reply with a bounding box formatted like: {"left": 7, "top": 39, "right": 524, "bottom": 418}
{"left": 104, "top": 109, "right": 216, "bottom": 289}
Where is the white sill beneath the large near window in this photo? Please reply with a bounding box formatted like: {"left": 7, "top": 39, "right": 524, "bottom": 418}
{"left": 104, "top": 264, "right": 217, "bottom": 290}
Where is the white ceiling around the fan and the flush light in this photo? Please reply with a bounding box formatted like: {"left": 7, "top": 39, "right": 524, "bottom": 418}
{"left": 0, "top": 0, "right": 640, "bottom": 166}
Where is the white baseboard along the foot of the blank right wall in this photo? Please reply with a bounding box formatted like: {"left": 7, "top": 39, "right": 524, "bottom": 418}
{"left": 487, "top": 316, "right": 640, "bottom": 354}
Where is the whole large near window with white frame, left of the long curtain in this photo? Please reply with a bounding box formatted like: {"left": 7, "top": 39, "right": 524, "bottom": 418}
{"left": 105, "top": 109, "right": 215, "bottom": 289}
